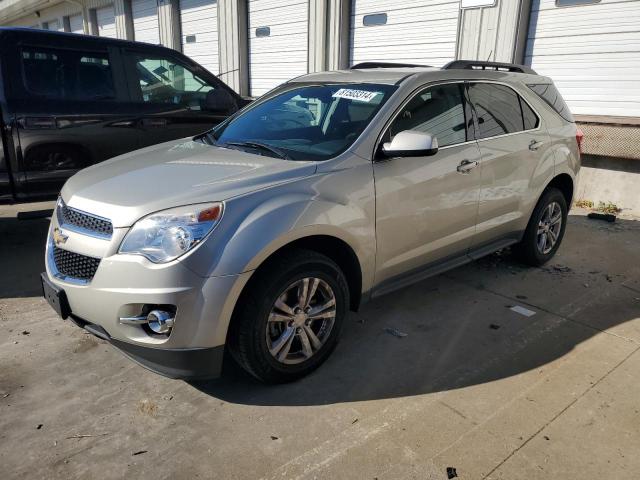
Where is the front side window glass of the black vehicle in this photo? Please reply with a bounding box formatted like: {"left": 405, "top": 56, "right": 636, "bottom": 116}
{"left": 135, "top": 56, "right": 215, "bottom": 110}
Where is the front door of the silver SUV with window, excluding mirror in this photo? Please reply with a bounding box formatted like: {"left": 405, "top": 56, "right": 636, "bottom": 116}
{"left": 373, "top": 83, "right": 480, "bottom": 286}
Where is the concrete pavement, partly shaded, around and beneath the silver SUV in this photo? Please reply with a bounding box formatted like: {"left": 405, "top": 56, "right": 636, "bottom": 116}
{"left": 0, "top": 202, "right": 640, "bottom": 480}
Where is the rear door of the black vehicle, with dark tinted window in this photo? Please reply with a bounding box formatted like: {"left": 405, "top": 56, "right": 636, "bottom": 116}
{"left": 11, "top": 43, "right": 140, "bottom": 198}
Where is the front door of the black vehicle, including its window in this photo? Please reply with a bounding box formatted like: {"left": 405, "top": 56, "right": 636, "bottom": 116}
{"left": 123, "top": 48, "right": 241, "bottom": 146}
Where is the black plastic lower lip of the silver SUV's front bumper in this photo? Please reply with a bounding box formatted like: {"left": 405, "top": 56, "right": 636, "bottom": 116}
{"left": 69, "top": 314, "right": 224, "bottom": 380}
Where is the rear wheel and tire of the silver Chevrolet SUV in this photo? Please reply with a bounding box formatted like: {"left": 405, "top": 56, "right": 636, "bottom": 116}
{"left": 513, "top": 188, "right": 567, "bottom": 267}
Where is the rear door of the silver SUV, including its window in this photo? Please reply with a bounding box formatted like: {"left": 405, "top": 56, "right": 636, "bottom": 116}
{"left": 468, "top": 82, "right": 554, "bottom": 249}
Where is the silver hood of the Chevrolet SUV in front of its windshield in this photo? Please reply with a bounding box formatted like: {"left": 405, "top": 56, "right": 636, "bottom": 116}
{"left": 62, "top": 140, "right": 316, "bottom": 228}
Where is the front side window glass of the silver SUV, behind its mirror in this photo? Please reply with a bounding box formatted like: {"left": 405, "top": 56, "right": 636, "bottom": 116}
{"left": 387, "top": 83, "right": 467, "bottom": 147}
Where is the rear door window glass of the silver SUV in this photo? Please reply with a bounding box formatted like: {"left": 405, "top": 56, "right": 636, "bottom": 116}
{"left": 469, "top": 83, "right": 524, "bottom": 139}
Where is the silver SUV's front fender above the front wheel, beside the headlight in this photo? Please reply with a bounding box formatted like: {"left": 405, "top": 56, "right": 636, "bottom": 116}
{"left": 185, "top": 165, "right": 375, "bottom": 290}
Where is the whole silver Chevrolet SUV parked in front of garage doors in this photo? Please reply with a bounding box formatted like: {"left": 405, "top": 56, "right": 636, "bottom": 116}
{"left": 42, "top": 61, "right": 581, "bottom": 382}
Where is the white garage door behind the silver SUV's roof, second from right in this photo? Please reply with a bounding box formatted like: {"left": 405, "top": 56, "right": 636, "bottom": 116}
{"left": 350, "top": 0, "right": 460, "bottom": 67}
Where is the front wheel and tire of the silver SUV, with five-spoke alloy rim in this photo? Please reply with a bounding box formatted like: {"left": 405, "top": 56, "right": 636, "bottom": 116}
{"left": 229, "top": 250, "right": 349, "bottom": 383}
